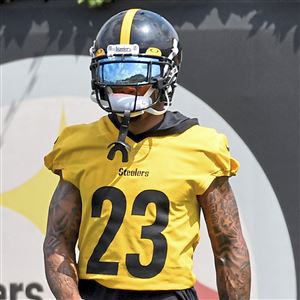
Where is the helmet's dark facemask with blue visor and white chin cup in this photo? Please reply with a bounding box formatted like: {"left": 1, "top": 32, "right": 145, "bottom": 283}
{"left": 91, "top": 49, "right": 178, "bottom": 117}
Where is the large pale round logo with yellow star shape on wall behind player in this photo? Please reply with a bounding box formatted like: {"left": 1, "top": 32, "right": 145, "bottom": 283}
{"left": 0, "top": 55, "right": 296, "bottom": 299}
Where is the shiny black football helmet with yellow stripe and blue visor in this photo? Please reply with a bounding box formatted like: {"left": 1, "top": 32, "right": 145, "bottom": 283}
{"left": 90, "top": 9, "right": 182, "bottom": 116}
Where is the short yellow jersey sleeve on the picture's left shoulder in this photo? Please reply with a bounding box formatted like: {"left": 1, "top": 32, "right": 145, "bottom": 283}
{"left": 44, "top": 127, "right": 78, "bottom": 187}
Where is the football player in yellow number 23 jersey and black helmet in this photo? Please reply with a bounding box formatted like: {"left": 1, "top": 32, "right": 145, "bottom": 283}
{"left": 44, "top": 9, "right": 250, "bottom": 300}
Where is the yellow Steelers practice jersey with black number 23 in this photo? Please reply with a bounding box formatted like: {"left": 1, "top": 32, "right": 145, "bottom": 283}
{"left": 45, "top": 112, "right": 238, "bottom": 290}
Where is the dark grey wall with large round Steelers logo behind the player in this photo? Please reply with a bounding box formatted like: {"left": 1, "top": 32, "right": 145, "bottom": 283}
{"left": 0, "top": 0, "right": 300, "bottom": 299}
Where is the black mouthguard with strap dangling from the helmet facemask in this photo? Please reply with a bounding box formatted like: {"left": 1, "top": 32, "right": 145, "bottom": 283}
{"left": 107, "top": 110, "right": 131, "bottom": 162}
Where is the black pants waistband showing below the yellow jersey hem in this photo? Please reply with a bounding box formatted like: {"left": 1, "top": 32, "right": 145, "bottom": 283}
{"left": 79, "top": 280, "right": 198, "bottom": 300}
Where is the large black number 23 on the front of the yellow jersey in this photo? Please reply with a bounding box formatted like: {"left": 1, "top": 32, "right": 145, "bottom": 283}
{"left": 87, "top": 187, "right": 170, "bottom": 278}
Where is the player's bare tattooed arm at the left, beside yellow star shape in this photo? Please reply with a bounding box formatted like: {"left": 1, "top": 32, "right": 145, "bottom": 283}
{"left": 43, "top": 178, "right": 81, "bottom": 300}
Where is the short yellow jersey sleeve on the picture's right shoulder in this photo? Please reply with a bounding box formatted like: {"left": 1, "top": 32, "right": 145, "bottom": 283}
{"left": 196, "top": 131, "right": 240, "bottom": 195}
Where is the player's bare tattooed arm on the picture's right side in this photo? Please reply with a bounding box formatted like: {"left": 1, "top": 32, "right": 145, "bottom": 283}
{"left": 199, "top": 177, "right": 251, "bottom": 300}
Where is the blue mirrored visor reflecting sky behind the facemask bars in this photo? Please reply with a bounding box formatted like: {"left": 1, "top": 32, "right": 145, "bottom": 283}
{"left": 97, "top": 56, "right": 165, "bottom": 85}
